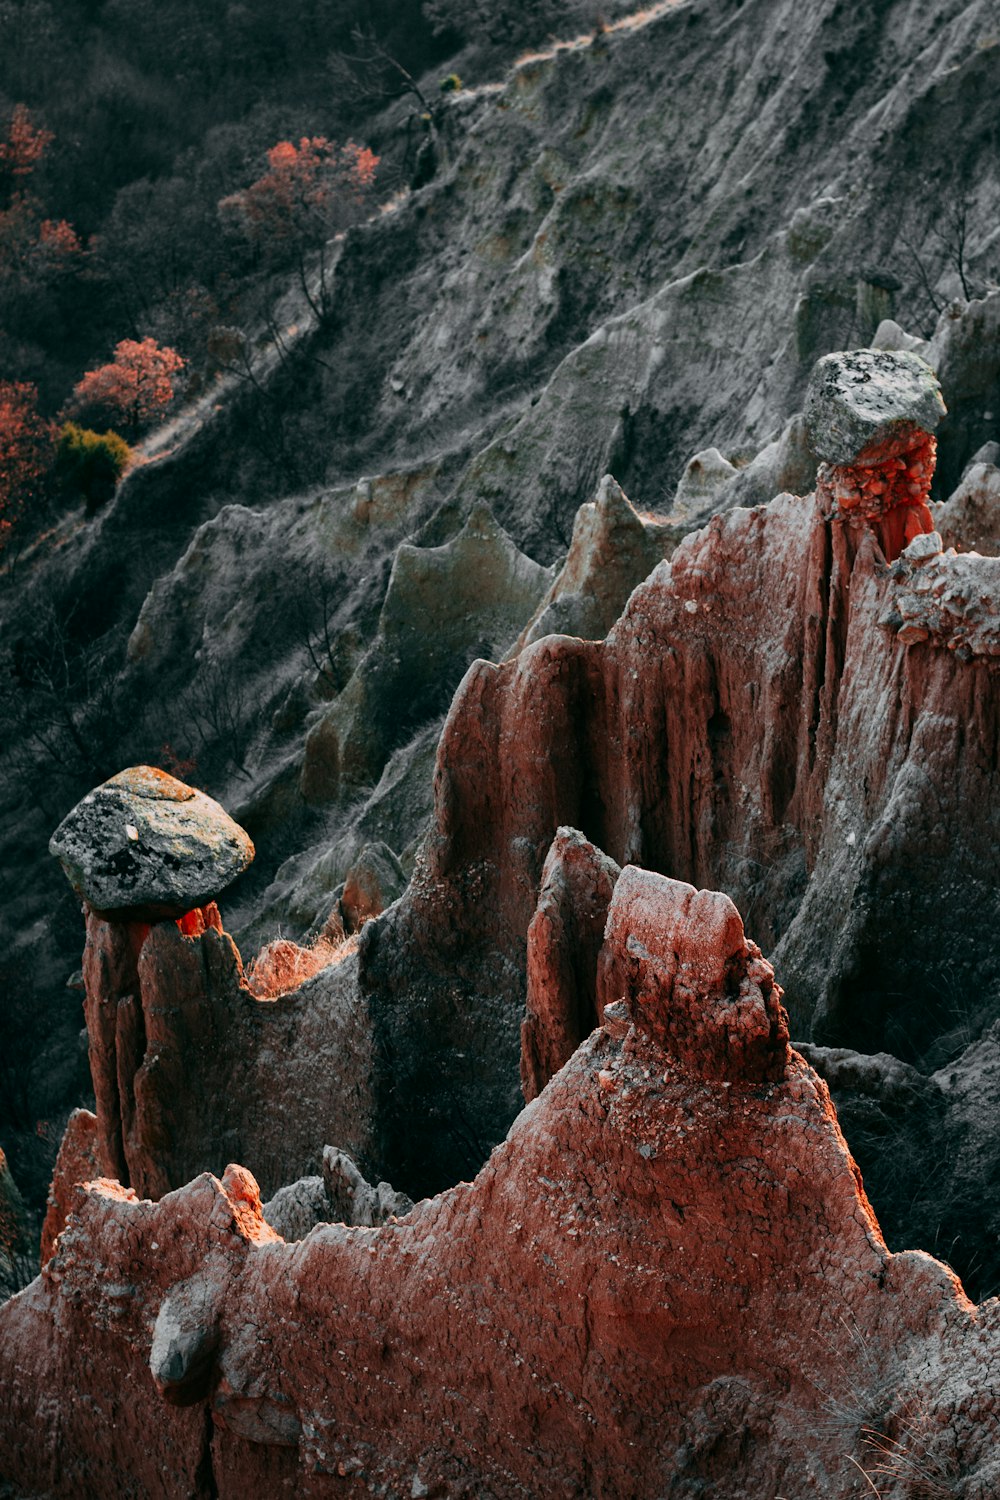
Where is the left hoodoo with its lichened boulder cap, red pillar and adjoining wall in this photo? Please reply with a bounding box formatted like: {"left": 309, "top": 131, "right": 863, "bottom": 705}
{"left": 43, "top": 767, "right": 372, "bottom": 1224}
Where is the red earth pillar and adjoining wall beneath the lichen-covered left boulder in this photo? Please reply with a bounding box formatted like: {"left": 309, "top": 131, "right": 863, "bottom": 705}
{"left": 84, "top": 905, "right": 372, "bottom": 1199}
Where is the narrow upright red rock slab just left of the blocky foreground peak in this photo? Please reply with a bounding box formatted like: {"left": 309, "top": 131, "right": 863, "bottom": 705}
{"left": 520, "top": 828, "right": 621, "bottom": 1100}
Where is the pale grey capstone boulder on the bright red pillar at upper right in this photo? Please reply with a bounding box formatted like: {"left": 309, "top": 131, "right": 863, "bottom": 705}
{"left": 805, "top": 350, "right": 945, "bottom": 464}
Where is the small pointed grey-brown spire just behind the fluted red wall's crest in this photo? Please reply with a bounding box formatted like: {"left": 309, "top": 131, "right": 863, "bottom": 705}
{"left": 511, "top": 474, "right": 685, "bottom": 656}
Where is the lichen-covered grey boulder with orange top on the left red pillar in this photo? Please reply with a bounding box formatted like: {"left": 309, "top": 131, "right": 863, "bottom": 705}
{"left": 48, "top": 765, "right": 253, "bottom": 920}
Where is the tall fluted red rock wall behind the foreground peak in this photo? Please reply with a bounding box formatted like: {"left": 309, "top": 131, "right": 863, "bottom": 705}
{"left": 361, "top": 495, "right": 1000, "bottom": 1194}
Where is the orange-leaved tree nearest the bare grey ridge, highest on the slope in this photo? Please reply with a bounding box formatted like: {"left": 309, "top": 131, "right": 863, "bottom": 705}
{"left": 219, "top": 135, "right": 379, "bottom": 318}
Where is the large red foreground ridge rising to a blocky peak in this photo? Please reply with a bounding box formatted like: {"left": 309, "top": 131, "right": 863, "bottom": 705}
{"left": 0, "top": 870, "right": 1000, "bottom": 1500}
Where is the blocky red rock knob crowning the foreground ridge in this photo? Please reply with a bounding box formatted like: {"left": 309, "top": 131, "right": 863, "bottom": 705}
{"left": 600, "top": 866, "right": 789, "bottom": 1083}
